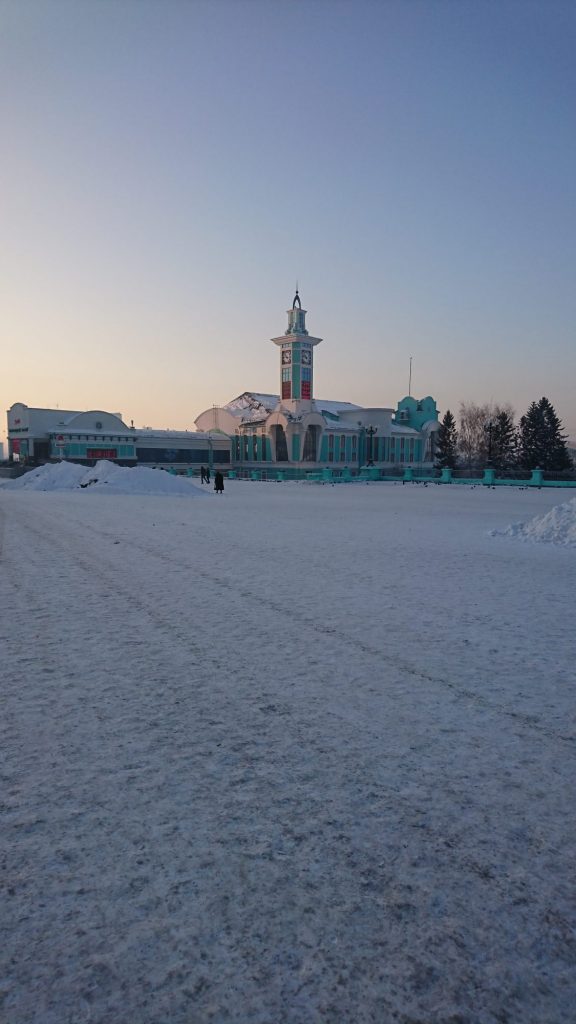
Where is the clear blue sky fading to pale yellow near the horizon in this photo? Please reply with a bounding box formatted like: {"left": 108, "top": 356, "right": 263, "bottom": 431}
{"left": 0, "top": 0, "right": 576, "bottom": 448}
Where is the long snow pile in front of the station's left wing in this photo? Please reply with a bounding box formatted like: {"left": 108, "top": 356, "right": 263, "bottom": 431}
{"left": 6, "top": 460, "right": 205, "bottom": 498}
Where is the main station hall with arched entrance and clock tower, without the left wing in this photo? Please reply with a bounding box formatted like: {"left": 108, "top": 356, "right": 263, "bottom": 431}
{"left": 195, "top": 291, "right": 440, "bottom": 471}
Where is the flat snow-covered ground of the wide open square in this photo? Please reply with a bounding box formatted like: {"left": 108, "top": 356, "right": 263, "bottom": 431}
{"left": 0, "top": 470, "right": 576, "bottom": 1024}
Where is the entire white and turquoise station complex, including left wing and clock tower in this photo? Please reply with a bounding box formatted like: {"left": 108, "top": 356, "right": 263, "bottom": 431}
{"left": 8, "top": 291, "right": 440, "bottom": 476}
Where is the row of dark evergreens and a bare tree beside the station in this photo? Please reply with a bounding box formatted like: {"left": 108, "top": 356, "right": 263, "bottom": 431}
{"left": 435, "top": 398, "right": 574, "bottom": 472}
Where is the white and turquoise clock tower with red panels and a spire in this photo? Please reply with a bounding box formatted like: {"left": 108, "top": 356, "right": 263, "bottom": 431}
{"left": 272, "top": 289, "right": 322, "bottom": 413}
